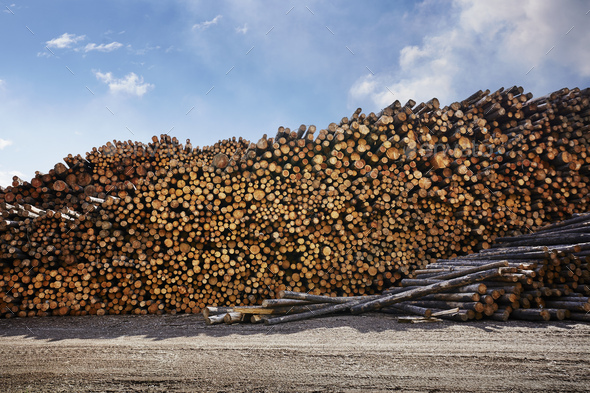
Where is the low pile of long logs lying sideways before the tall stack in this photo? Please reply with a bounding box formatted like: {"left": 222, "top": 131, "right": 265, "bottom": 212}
{"left": 212, "top": 214, "right": 590, "bottom": 325}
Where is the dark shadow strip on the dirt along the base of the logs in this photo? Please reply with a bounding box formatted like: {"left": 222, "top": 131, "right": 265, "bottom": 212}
{"left": 0, "top": 313, "right": 580, "bottom": 341}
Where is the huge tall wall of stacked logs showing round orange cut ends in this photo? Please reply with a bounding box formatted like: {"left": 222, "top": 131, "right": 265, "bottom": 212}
{"left": 0, "top": 86, "right": 590, "bottom": 316}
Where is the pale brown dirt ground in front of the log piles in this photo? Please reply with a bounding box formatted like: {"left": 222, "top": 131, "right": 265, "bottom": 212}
{"left": 0, "top": 314, "right": 590, "bottom": 393}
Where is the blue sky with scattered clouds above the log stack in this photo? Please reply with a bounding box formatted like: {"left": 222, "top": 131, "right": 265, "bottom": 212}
{"left": 0, "top": 0, "right": 590, "bottom": 186}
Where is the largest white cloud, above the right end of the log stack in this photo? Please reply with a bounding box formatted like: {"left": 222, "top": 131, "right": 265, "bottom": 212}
{"left": 349, "top": 0, "right": 590, "bottom": 108}
